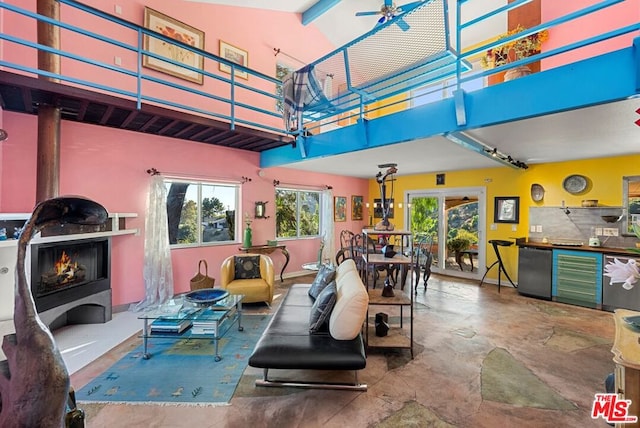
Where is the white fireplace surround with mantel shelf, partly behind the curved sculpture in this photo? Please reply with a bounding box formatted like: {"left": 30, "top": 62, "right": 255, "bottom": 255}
{"left": 0, "top": 213, "right": 140, "bottom": 324}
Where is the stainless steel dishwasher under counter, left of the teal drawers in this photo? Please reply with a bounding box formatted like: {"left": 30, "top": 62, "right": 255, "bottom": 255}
{"left": 518, "top": 247, "right": 553, "bottom": 300}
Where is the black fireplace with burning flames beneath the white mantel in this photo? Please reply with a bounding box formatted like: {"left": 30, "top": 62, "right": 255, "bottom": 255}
{"left": 31, "top": 237, "right": 111, "bottom": 329}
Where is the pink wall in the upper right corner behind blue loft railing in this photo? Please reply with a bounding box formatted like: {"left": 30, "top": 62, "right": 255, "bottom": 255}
{"left": 542, "top": 0, "right": 640, "bottom": 69}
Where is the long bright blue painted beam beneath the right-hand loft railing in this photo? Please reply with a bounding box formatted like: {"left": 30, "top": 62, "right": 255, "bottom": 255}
{"left": 260, "top": 45, "right": 640, "bottom": 167}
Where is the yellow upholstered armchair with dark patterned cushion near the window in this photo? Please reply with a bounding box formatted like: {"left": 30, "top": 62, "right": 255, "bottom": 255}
{"left": 220, "top": 253, "right": 275, "bottom": 305}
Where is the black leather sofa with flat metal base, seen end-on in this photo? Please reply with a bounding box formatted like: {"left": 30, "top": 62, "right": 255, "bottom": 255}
{"left": 249, "top": 266, "right": 368, "bottom": 391}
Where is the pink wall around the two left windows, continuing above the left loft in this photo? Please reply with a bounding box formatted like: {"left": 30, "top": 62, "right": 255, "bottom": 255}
{"left": 0, "top": 0, "right": 369, "bottom": 305}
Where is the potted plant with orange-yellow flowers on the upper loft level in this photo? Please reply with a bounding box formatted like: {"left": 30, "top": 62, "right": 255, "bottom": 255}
{"left": 481, "top": 25, "right": 549, "bottom": 80}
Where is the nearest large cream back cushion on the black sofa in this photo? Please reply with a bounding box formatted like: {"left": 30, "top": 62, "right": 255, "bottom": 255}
{"left": 329, "top": 271, "right": 369, "bottom": 340}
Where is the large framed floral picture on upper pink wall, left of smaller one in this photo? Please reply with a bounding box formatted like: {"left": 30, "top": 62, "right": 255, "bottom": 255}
{"left": 142, "top": 7, "right": 204, "bottom": 85}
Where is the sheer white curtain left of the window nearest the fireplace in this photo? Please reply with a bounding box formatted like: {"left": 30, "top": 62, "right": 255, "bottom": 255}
{"left": 131, "top": 175, "right": 173, "bottom": 311}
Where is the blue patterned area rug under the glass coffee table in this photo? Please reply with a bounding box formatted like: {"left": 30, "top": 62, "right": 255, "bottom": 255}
{"left": 76, "top": 314, "right": 270, "bottom": 405}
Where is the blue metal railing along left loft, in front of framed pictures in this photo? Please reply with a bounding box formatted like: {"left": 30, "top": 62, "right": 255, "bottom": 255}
{"left": 0, "top": 0, "right": 287, "bottom": 134}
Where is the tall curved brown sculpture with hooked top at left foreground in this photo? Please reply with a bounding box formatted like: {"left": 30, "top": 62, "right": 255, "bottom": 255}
{"left": 0, "top": 196, "right": 108, "bottom": 428}
